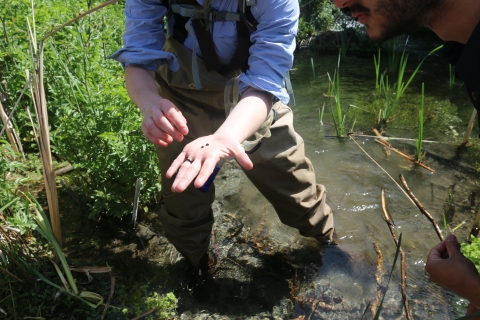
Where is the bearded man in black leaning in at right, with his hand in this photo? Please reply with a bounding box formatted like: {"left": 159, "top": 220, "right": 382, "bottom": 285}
{"left": 334, "top": 0, "right": 480, "bottom": 320}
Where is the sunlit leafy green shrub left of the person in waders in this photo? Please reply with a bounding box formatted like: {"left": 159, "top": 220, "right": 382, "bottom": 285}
{"left": 0, "top": 0, "right": 160, "bottom": 218}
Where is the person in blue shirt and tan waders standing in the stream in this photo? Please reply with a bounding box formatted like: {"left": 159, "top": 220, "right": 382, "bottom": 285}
{"left": 111, "top": 0, "right": 336, "bottom": 300}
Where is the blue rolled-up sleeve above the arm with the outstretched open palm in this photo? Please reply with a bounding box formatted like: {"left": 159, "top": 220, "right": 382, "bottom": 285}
{"left": 239, "top": 0, "right": 299, "bottom": 104}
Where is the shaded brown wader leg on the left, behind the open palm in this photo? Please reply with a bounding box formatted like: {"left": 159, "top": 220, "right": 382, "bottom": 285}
{"left": 156, "top": 85, "right": 225, "bottom": 266}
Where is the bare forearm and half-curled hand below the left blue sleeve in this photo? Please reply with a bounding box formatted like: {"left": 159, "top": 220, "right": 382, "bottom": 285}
{"left": 125, "top": 65, "right": 188, "bottom": 147}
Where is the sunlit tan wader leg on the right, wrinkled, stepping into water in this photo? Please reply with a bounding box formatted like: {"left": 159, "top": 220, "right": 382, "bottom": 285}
{"left": 245, "top": 103, "right": 333, "bottom": 242}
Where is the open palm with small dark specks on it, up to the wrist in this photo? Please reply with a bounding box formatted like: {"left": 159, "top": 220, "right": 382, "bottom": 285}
{"left": 166, "top": 134, "right": 253, "bottom": 192}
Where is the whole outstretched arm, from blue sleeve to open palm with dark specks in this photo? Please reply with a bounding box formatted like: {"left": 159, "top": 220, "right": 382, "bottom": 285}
{"left": 167, "top": 0, "right": 299, "bottom": 192}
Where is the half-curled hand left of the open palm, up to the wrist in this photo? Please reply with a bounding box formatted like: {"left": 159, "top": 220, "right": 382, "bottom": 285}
{"left": 140, "top": 96, "right": 188, "bottom": 147}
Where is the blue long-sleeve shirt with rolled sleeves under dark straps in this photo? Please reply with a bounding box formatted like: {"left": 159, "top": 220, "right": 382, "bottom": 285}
{"left": 111, "top": 0, "right": 299, "bottom": 104}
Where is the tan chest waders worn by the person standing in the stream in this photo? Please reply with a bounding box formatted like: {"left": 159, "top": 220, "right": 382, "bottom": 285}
{"left": 157, "top": 38, "right": 333, "bottom": 266}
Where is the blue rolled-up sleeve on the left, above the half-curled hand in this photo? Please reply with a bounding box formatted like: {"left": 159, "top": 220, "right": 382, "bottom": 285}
{"left": 109, "top": 0, "right": 180, "bottom": 71}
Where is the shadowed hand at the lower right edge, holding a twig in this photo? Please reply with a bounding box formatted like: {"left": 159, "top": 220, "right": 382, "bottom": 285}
{"left": 425, "top": 235, "right": 480, "bottom": 319}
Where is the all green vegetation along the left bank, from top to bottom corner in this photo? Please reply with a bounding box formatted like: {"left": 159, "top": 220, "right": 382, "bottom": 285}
{"left": 0, "top": 0, "right": 176, "bottom": 319}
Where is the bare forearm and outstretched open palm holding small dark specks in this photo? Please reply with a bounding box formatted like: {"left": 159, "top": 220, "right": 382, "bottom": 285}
{"left": 166, "top": 88, "right": 272, "bottom": 192}
